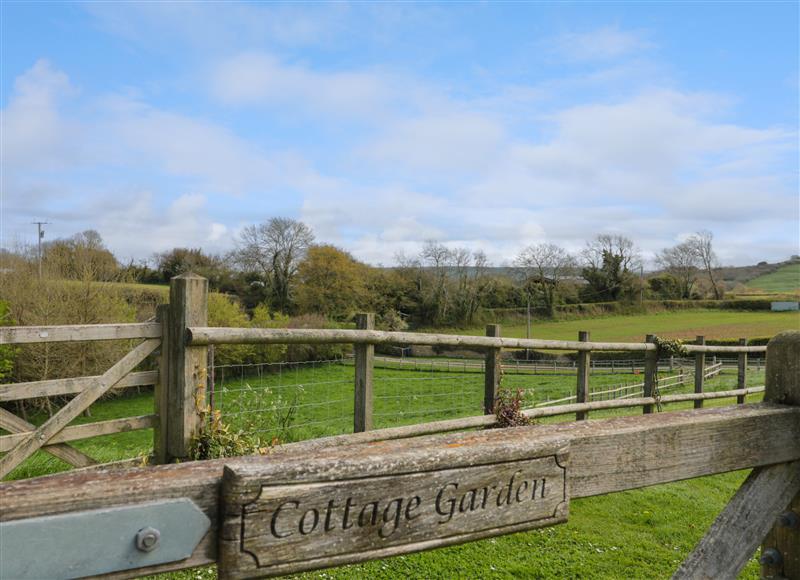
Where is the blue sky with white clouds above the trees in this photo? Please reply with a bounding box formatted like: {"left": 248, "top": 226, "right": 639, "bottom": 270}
{"left": 0, "top": 0, "right": 800, "bottom": 266}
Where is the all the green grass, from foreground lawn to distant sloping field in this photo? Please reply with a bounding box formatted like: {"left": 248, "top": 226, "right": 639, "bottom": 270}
{"left": 1, "top": 311, "right": 788, "bottom": 580}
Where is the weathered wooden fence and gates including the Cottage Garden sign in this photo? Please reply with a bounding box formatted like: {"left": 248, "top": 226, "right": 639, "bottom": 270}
{"left": 0, "top": 275, "right": 800, "bottom": 578}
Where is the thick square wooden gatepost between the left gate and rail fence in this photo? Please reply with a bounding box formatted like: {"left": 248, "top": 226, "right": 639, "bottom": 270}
{"left": 163, "top": 274, "right": 208, "bottom": 461}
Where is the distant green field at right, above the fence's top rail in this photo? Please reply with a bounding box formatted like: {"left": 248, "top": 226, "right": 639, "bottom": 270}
{"left": 440, "top": 310, "right": 800, "bottom": 342}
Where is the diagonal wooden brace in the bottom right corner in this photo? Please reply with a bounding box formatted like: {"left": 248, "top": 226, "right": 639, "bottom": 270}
{"left": 672, "top": 461, "right": 800, "bottom": 580}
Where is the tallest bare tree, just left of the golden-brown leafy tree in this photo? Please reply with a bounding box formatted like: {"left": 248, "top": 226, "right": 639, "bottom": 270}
{"left": 233, "top": 218, "right": 314, "bottom": 312}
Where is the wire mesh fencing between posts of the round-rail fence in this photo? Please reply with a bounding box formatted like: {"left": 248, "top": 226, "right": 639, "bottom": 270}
{"left": 208, "top": 356, "right": 764, "bottom": 443}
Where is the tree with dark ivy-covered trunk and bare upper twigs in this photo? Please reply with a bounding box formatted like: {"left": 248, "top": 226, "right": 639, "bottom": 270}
{"left": 581, "top": 234, "right": 641, "bottom": 302}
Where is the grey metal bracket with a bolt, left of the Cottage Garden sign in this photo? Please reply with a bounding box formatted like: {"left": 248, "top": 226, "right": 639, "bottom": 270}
{"left": 0, "top": 498, "right": 211, "bottom": 580}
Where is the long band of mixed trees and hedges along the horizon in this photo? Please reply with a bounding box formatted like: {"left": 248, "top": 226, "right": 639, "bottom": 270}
{"left": 4, "top": 217, "right": 724, "bottom": 329}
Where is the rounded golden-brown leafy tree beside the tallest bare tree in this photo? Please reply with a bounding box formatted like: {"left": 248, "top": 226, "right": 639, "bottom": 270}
{"left": 296, "top": 245, "right": 369, "bottom": 320}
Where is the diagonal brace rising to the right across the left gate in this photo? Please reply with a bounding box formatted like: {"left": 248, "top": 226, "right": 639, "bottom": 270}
{"left": 0, "top": 338, "right": 161, "bottom": 477}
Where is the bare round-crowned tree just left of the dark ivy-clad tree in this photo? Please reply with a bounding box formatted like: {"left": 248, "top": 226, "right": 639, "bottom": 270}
{"left": 514, "top": 244, "right": 577, "bottom": 316}
